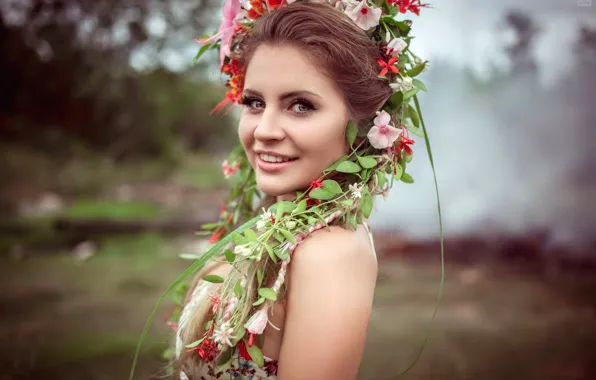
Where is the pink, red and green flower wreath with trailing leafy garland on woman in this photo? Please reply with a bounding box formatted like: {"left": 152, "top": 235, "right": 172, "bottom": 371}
{"left": 130, "top": 0, "right": 443, "bottom": 379}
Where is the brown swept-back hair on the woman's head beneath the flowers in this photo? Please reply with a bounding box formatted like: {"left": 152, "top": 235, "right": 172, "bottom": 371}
{"left": 241, "top": 1, "right": 392, "bottom": 123}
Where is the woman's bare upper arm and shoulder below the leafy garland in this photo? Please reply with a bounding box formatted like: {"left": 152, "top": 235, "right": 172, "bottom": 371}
{"left": 278, "top": 228, "right": 377, "bottom": 380}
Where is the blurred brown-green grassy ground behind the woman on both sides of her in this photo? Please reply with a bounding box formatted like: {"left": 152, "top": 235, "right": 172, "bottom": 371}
{"left": 0, "top": 246, "right": 596, "bottom": 380}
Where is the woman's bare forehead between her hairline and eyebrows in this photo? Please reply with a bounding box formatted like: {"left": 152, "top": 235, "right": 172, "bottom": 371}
{"left": 244, "top": 45, "right": 337, "bottom": 95}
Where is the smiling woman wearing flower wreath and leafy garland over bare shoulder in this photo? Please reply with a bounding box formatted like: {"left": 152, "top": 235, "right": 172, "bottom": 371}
{"left": 156, "top": 0, "right": 424, "bottom": 380}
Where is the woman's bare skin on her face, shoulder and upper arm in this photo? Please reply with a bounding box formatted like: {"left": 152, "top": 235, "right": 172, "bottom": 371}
{"left": 236, "top": 45, "right": 377, "bottom": 380}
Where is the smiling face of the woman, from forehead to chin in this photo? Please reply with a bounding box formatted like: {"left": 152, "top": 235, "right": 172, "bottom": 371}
{"left": 239, "top": 45, "right": 349, "bottom": 199}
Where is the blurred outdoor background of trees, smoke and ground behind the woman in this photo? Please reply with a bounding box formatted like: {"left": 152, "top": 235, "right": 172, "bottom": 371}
{"left": 0, "top": 0, "right": 596, "bottom": 380}
